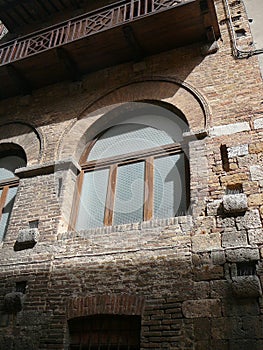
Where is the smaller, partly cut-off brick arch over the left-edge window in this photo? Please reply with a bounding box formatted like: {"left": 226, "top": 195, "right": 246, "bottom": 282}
{"left": 0, "top": 122, "right": 42, "bottom": 165}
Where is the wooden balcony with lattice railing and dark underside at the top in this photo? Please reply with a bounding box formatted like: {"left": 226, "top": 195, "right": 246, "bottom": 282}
{"left": 0, "top": 0, "right": 219, "bottom": 98}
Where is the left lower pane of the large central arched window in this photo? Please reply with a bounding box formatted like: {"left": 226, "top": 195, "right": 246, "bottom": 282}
{"left": 76, "top": 169, "right": 109, "bottom": 230}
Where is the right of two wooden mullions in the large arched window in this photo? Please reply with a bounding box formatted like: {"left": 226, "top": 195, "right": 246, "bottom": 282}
{"left": 144, "top": 157, "right": 154, "bottom": 221}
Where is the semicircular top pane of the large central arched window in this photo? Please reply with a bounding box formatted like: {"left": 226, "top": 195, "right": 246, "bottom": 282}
{"left": 88, "top": 124, "right": 174, "bottom": 161}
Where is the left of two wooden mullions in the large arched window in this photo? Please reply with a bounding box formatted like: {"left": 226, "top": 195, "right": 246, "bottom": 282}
{"left": 104, "top": 164, "right": 118, "bottom": 226}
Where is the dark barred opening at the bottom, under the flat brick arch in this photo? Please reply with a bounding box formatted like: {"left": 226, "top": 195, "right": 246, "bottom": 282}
{"left": 68, "top": 315, "right": 141, "bottom": 350}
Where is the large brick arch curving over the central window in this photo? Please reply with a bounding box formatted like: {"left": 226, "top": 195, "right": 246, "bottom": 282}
{"left": 58, "top": 77, "right": 210, "bottom": 160}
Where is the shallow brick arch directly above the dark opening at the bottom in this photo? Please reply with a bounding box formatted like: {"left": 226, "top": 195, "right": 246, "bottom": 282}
{"left": 67, "top": 294, "right": 145, "bottom": 319}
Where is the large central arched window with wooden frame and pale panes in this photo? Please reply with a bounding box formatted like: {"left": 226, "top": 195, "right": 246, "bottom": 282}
{"left": 72, "top": 105, "right": 188, "bottom": 230}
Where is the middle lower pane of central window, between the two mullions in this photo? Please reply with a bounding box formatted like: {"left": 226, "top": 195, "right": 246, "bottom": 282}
{"left": 113, "top": 162, "right": 145, "bottom": 225}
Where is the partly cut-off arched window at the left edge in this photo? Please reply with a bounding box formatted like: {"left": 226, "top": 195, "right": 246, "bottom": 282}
{"left": 0, "top": 145, "right": 26, "bottom": 240}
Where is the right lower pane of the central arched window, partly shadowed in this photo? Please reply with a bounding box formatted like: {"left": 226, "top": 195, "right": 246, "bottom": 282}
{"left": 154, "top": 153, "right": 186, "bottom": 218}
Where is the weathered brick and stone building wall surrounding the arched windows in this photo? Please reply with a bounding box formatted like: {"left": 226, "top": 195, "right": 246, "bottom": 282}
{"left": 0, "top": 0, "right": 263, "bottom": 350}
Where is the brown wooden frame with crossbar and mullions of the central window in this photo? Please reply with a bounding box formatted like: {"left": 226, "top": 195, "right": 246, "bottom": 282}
{"left": 70, "top": 138, "right": 190, "bottom": 229}
